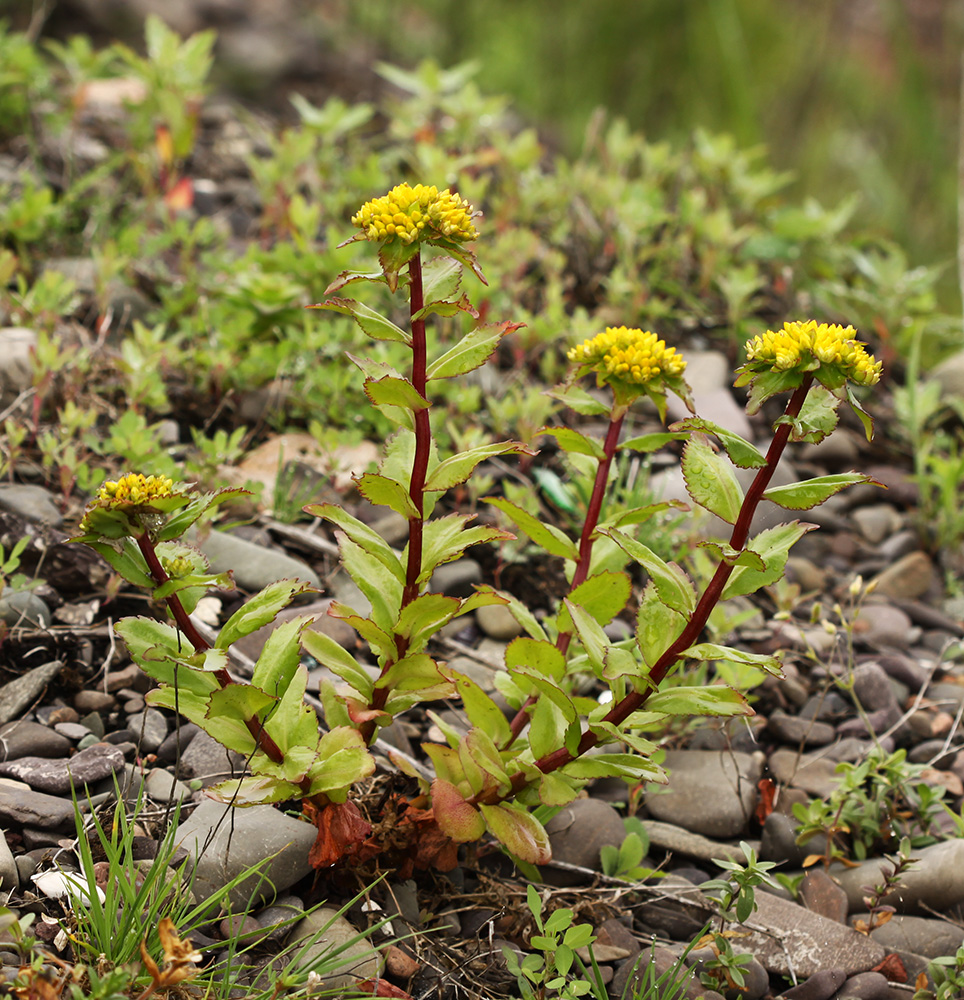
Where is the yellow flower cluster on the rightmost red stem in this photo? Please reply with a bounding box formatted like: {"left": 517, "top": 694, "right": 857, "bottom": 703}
{"left": 746, "top": 320, "right": 881, "bottom": 385}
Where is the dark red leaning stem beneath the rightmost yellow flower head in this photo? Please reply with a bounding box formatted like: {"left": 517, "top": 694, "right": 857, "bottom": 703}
{"left": 470, "top": 375, "right": 813, "bottom": 803}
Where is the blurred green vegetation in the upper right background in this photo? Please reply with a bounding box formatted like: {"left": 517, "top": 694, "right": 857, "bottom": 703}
{"left": 342, "top": 0, "right": 964, "bottom": 309}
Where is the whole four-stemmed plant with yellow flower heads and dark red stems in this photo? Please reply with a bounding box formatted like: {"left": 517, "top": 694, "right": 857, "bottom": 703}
{"left": 73, "top": 184, "right": 880, "bottom": 866}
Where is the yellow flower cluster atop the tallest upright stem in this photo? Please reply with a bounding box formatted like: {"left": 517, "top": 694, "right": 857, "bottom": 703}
{"left": 351, "top": 184, "right": 479, "bottom": 243}
